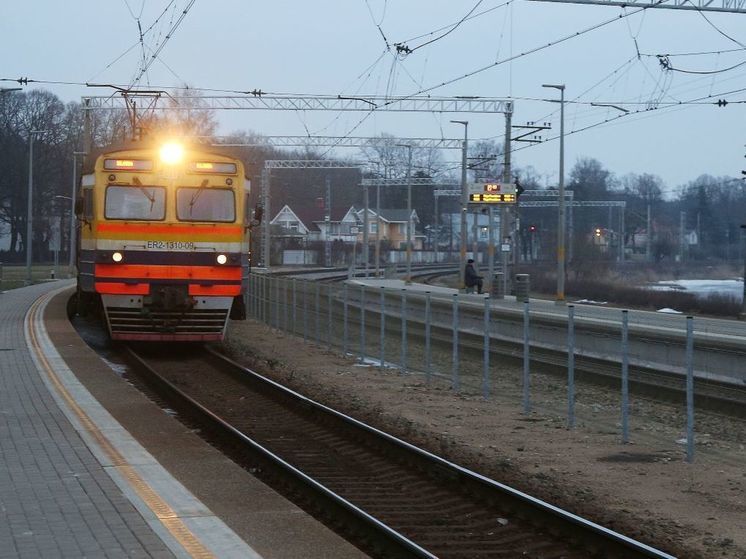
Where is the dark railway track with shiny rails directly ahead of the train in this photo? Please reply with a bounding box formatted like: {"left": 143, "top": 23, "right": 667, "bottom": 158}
{"left": 122, "top": 348, "right": 671, "bottom": 559}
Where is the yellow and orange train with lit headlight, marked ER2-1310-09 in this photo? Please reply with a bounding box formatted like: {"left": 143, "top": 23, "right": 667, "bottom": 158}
{"left": 77, "top": 143, "right": 250, "bottom": 341}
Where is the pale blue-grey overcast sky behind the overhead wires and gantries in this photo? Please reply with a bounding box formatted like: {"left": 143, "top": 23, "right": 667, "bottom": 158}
{"left": 0, "top": 0, "right": 746, "bottom": 190}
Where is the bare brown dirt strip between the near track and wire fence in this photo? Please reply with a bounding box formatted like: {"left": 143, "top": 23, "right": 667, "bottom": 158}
{"left": 225, "top": 320, "right": 746, "bottom": 559}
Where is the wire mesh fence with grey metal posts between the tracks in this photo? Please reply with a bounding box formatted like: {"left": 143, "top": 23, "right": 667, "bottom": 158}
{"left": 248, "top": 274, "right": 694, "bottom": 462}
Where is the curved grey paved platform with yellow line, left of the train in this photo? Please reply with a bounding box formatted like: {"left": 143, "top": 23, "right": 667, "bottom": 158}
{"left": 0, "top": 281, "right": 365, "bottom": 559}
